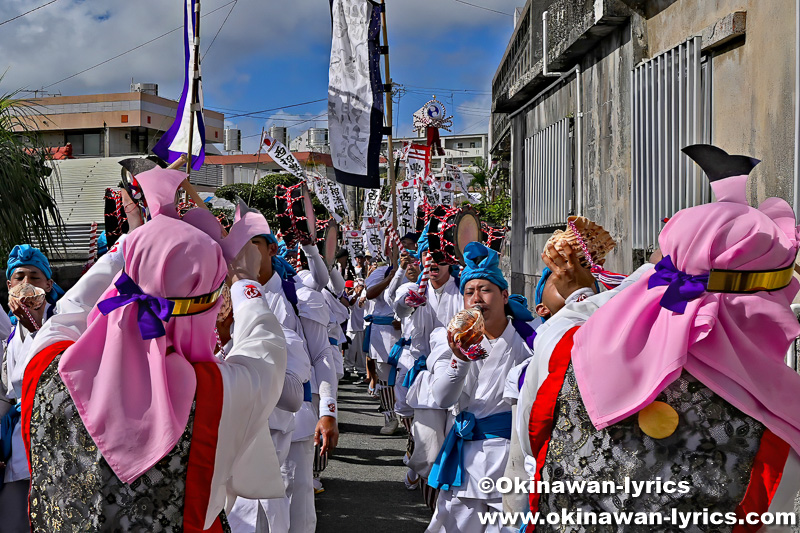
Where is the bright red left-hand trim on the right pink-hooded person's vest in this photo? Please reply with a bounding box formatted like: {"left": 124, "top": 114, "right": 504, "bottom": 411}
{"left": 525, "top": 326, "right": 580, "bottom": 533}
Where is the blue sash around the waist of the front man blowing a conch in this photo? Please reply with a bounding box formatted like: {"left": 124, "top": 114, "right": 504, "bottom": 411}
{"left": 428, "top": 411, "right": 511, "bottom": 490}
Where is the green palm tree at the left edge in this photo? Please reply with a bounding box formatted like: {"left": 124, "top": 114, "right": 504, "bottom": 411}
{"left": 0, "top": 87, "right": 64, "bottom": 265}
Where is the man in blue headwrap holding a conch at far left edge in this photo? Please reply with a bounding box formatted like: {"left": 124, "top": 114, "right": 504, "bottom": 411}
{"left": 0, "top": 244, "right": 64, "bottom": 532}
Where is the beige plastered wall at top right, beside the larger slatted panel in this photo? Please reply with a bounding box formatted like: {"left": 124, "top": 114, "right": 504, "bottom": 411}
{"left": 647, "top": 0, "right": 796, "bottom": 204}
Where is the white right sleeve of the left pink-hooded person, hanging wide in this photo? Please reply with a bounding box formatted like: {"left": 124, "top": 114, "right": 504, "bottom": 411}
{"left": 212, "top": 280, "right": 286, "bottom": 528}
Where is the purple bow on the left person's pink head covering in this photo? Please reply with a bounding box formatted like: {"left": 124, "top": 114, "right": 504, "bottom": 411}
{"left": 97, "top": 272, "right": 175, "bottom": 340}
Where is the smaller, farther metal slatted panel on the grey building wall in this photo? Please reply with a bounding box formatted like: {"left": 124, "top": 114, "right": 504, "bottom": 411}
{"left": 522, "top": 118, "right": 572, "bottom": 228}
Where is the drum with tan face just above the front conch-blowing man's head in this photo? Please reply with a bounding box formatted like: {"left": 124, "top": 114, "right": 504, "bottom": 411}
{"left": 428, "top": 205, "right": 481, "bottom": 265}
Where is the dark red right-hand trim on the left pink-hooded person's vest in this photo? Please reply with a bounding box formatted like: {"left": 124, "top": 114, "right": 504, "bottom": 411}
{"left": 183, "top": 363, "right": 223, "bottom": 533}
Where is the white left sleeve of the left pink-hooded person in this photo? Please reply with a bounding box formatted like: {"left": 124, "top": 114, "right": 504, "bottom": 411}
{"left": 28, "top": 244, "right": 125, "bottom": 364}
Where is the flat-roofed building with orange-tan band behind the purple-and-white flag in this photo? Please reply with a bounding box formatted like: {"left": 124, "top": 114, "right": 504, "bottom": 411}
{"left": 14, "top": 84, "right": 225, "bottom": 157}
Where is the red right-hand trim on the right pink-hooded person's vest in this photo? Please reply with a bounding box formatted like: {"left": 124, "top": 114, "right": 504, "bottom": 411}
{"left": 733, "top": 429, "right": 790, "bottom": 533}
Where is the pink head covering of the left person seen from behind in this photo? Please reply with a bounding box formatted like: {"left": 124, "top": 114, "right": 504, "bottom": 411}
{"left": 59, "top": 169, "right": 266, "bottom": 483}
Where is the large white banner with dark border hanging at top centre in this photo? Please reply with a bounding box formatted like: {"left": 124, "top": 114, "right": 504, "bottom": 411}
{"left": 328, "top": 0, "right": 384, "bottom": 188}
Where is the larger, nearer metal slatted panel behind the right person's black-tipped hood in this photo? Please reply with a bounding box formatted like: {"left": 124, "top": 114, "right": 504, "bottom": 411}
{"left": 631, "top": 37, "right": 711, "bottom": 250}
